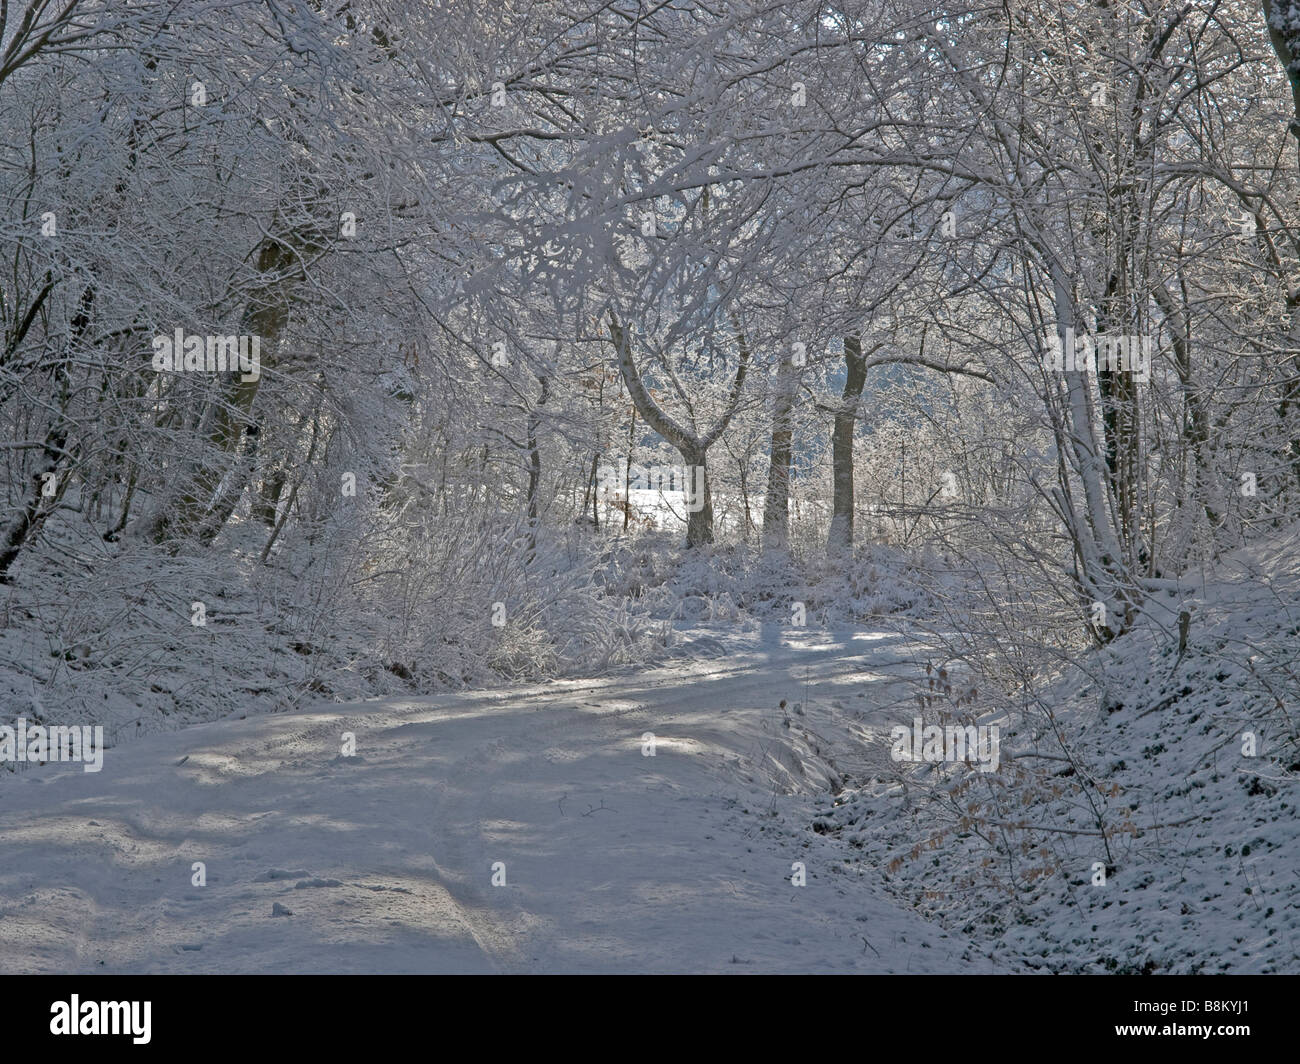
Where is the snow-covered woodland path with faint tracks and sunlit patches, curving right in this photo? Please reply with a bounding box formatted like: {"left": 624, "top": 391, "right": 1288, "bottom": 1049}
{"left": 0, "top": 632, "right": 989, "bottom": 973}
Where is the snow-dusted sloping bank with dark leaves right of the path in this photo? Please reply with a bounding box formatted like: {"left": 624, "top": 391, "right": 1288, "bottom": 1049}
{"left": 815, "top": 525, "right": 1300, "bottom": 974}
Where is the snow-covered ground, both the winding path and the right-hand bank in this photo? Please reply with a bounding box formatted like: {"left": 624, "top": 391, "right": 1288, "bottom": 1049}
{"left": 0, "top": 527, "right": 1300, "bottom": 973}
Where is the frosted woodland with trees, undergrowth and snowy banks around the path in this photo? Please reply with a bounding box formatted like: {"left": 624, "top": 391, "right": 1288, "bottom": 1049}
{"left": 0, "top": 0, "right": 1300, "bottom": 972}
